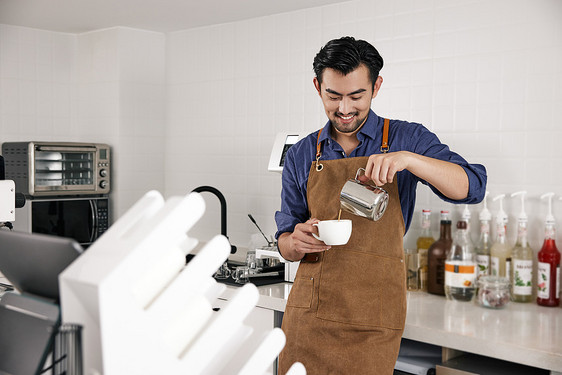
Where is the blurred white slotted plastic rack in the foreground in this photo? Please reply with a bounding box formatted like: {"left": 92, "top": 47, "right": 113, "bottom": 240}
{"left": 59, "top": 191, "right": 306, "bottom": 375}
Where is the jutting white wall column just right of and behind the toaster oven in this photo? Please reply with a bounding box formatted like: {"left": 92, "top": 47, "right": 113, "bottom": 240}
{"left": 77, "top": 27, "right": 166, "bottom": 217}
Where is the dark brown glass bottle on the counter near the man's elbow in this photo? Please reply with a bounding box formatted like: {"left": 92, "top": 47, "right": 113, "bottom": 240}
{"left": 427, "top": 211, "right": 453, "bottom": 296}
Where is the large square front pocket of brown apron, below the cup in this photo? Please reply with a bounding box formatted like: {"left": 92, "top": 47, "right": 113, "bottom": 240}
{"left": 317, "top": 253, "right": 406, "bottom": 329}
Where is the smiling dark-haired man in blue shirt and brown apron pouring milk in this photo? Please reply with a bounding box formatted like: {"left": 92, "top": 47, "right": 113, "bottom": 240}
{"left": 275, "top": 37, "right": 487, "bottom": 375}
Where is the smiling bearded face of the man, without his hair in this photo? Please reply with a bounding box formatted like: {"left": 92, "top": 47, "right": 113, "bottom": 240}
{"left": 314, "top": 64, "right": 382, "bottom": 135}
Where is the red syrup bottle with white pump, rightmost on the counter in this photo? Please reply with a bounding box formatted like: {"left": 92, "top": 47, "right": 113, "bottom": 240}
{"left": 537, "top": 193, "right": 560, "bottom": 307}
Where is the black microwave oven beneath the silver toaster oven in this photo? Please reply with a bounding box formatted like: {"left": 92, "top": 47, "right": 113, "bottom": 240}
{"left": 13, "top": 196, "right": 109, "bottom": 248}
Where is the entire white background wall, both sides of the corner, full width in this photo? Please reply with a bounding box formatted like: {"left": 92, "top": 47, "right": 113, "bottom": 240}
{"left": 0, "top": 0, "right": 562, "bottom": 253}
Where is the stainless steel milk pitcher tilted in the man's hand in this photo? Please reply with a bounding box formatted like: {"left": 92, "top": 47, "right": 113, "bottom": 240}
{"left": 340, "top": 168, "right": 388, "bottom": 221}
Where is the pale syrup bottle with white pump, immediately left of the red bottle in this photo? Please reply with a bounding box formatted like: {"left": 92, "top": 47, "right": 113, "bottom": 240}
{"left": 511, "top": 191, "right": 534, "bottom": 302}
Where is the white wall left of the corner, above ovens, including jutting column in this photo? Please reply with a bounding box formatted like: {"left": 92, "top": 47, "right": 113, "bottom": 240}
{"left": 0, "top": 25, "right": 166, "bottom": 217}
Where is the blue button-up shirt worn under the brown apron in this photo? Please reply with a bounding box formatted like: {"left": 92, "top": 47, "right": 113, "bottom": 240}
{"left": 275, "top": 110, "right": 487, "bottom": 238}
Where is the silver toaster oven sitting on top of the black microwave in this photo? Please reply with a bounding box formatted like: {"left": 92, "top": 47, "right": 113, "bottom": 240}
{"left": 2, "top": 142, "right": 111, "bottom": 197}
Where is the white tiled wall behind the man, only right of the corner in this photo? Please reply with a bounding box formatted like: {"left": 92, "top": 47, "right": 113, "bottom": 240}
{"left": 166, "top": 0, "right": 562, "bottom": 254}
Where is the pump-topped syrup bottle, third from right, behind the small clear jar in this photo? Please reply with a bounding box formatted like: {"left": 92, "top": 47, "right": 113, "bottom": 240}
{"left": 490, "top": 194, "right": 511, "bottom": 278}
